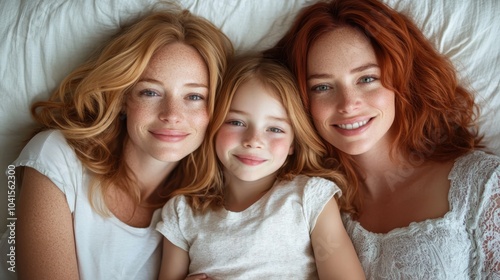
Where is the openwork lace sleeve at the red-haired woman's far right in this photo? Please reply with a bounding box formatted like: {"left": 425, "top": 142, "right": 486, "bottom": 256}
{"left": 477, "top": 166, "right": 500, "bottom": 279}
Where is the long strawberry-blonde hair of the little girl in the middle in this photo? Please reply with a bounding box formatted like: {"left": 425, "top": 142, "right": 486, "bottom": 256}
{"left": 172, "top": 54, "right": 346, "bottom": 212}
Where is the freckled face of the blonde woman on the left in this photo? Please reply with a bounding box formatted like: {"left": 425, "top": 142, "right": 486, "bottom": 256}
{"left": 125, "top": 43, "right": 209, "bottom": 162}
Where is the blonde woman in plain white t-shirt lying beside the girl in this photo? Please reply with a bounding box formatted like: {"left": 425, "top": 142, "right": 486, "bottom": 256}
{"left": 13, "top": 7, "right": 233, "bottom": 280}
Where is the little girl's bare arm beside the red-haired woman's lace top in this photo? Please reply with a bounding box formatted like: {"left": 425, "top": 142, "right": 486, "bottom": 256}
{"left": 311, "top": 198, "right": 365, "bottom": 279}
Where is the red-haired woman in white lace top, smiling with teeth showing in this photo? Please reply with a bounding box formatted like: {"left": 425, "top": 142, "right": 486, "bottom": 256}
{"left": 266, "top": 0, "right": 500, "bottom": 279}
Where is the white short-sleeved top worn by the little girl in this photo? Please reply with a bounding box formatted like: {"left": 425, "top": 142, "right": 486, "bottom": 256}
{"left": 157, "top": 175, "right": 341, "bottom": 279}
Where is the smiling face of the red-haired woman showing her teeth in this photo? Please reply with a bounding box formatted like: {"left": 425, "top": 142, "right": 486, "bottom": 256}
{"left": 307, "top": 27, "right": 395, "bottom": 155}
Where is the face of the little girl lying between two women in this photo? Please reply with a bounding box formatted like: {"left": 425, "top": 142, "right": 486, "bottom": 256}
{"left": 215, "top": 78, "right": 294, "bottom": 182}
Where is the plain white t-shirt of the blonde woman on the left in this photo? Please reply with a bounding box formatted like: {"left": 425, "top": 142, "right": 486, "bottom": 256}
{"left": 2, "top": 130, "right": 162, "bottom": 280}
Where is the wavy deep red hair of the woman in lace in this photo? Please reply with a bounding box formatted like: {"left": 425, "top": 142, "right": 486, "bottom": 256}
{"left": 265, "top": 0, "right": 481, "bottom": 215}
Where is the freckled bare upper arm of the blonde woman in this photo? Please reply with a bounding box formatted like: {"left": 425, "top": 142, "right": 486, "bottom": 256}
{"left": 16, "top": 167, "right": 79, "bottom": 280}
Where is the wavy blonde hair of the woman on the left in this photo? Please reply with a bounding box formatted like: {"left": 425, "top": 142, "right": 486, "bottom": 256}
{"left": 31, "top": 10, "right": 233, "bottom": 213}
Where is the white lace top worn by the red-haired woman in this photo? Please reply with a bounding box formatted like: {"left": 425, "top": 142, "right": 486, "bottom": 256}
{"left": 343, "top": 151, "right": 500, "bottom": 280}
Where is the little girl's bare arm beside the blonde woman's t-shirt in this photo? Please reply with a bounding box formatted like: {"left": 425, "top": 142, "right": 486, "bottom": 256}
{"left": 158, "top": 237, "right": 190, "bottom": 280}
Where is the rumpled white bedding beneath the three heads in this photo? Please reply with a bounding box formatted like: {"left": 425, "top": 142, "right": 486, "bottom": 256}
{"left": 0, "top": 0, "right": 500, "bottom": 231}
